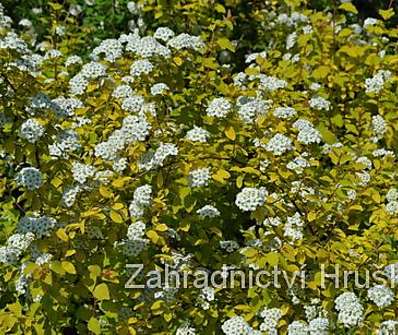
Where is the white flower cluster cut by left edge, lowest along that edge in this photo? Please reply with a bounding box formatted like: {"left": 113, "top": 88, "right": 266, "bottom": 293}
{"left": 0, "top": 233, "right": 35, "bottom": 264}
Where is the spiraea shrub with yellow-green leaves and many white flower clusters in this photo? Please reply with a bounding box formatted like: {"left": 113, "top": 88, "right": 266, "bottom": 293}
{"left": 0, "top": 1, "right": 398, "bottom": 335}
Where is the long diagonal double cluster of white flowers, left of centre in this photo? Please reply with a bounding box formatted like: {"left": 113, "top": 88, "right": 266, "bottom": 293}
{"left": 95, "top": 115, "right": 151, "bottom": 160}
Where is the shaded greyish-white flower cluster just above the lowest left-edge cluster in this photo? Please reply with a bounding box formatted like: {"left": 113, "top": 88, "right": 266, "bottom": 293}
{"left": 17, "top": 216, "right": 57, "bottom": 239}
